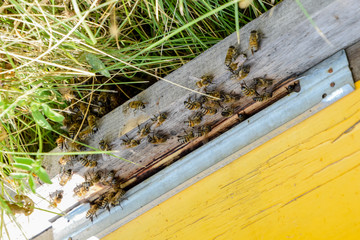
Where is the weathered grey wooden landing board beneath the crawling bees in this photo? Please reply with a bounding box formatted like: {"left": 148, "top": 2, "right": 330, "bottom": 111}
{"left": 43, "top": 0, "right": 360, "bottom": 208}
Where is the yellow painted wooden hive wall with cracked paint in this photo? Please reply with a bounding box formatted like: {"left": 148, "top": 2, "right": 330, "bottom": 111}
{"left": 104, "top": 90, "right": 360, "bottom": 240}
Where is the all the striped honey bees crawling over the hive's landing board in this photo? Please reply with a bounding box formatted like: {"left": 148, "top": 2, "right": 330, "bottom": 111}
{"left": 50, "top": 31, "right": 300, "bottom": 221}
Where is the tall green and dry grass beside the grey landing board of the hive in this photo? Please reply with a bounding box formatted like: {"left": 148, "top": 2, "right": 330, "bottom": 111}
{"left": 0, "top": 0, "right": 280, "bottom": 238}
